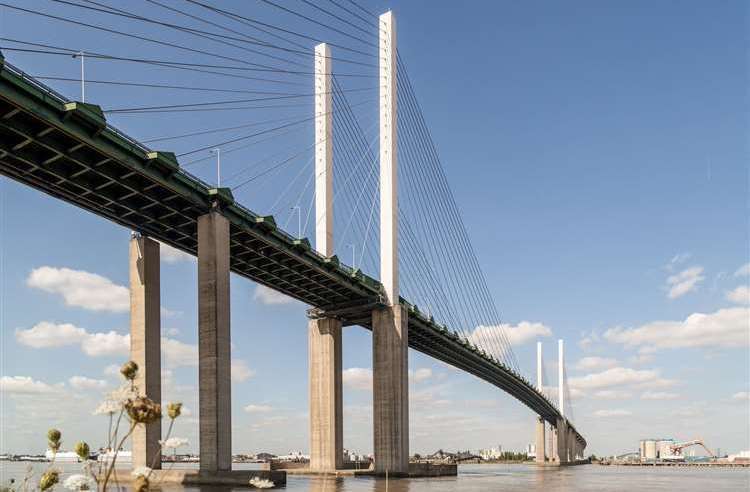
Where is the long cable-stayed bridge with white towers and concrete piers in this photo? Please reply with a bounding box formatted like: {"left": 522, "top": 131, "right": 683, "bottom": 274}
{"left": 0, "top": 0, "right": 586, "bottom": 474}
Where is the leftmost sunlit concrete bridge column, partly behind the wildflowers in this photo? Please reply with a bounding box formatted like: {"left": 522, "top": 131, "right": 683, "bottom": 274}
{"left": 130, "top": 233, "right": 161, "bottom": 468}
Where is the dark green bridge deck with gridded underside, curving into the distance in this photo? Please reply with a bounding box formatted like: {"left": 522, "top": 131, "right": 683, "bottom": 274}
{"left": 0, "top": 54, "right": 586, "bottom": 447}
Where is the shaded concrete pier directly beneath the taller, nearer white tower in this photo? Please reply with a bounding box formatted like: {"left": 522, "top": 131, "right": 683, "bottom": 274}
{"left": 372, "top": 305, "right": 409, "bottom": 476}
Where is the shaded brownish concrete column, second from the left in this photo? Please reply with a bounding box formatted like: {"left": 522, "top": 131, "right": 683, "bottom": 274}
{"left": 198, "top": 211, "right": 232, "bottom": 472}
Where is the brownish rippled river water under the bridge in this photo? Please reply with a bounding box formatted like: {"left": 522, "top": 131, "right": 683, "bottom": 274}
{"left": 0, "top": 462, "right": 750, "bottom": 492}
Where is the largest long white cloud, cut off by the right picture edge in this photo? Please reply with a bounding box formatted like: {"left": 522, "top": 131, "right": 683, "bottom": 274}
{"left": 604, "top": 307, "right": 750, "bottom": 353}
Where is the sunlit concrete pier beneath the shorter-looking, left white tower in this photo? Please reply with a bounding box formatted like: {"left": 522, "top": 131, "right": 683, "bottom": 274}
{"left": 308, "top": 318, "right": 344, "bottom": 472}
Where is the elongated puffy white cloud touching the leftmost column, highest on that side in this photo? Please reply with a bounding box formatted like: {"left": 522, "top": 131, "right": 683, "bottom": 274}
{"left": 26, "top": 266, "right": 130, "bottom": 313}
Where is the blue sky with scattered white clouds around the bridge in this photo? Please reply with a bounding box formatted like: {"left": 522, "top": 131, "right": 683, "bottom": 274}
{"left": 0, "top": 0, "right": 750, "bottom": 453}
